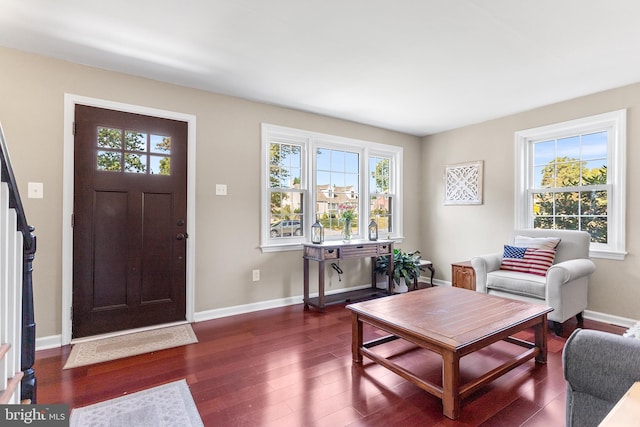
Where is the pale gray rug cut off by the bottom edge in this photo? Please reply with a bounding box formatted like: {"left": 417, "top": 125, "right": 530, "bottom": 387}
{"left": 70, "top": 379, "right": 204, "bottom": 427}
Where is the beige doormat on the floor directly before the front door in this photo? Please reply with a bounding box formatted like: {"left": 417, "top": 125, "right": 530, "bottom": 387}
{"left": 63, "top": 325, "right": 198, "bottom": 369}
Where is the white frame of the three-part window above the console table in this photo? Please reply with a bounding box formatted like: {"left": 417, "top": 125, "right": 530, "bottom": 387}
{"left": 260, "top": 123, "right": 403, "bottom": 252}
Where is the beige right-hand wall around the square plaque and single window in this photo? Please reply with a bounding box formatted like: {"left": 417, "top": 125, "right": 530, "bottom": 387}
{"left": 420, "top": 84, "right": 640, "bottom": 319}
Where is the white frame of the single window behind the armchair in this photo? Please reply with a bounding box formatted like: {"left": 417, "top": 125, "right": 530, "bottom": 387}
{"left": 514, "top": 109, "right": 627, "bottom": 260}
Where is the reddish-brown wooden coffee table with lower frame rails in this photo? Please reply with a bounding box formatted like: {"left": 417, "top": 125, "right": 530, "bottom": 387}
{"left": 347, "top": 286, "right": 553, "bottom": 419}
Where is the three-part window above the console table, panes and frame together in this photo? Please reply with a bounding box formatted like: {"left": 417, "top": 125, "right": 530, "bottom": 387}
{"left": 261, "top": 124, "right": 402, "bottom": 251}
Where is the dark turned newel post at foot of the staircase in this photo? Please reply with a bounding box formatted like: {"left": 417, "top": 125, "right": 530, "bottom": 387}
{"left": 20, "top": 226, "right": 37, "bottom": 404}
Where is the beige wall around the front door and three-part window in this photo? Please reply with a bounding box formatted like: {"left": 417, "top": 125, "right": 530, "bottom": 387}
{"left": 0, "top": 49, "right": 422, "bottom": 337}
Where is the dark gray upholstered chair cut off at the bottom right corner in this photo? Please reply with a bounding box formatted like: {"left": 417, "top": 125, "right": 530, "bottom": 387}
{"left": 562, "top": 329, "right": 640, "bottom": 427}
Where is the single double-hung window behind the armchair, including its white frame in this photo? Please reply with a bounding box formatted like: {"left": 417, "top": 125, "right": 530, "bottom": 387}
{"left": 515, "top": 110, "right": 626, "bottom": 259}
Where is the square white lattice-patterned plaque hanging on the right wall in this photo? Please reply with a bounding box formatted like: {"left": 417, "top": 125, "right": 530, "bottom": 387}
{"left": 444, "top": 160, "right": 483, "bottom": 205}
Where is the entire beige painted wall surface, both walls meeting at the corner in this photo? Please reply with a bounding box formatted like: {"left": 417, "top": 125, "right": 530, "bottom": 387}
{"left": 0, "top": 43, "right": 640, "bottom": 337}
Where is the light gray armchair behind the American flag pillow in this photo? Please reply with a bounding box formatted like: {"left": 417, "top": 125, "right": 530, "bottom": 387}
{"left": 471, "top": 229, "right": 595, "bottom": 335}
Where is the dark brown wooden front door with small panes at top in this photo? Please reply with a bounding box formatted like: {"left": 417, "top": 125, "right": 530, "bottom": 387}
{"left": 72, "top": 105, "right": 187, "bottom": 338}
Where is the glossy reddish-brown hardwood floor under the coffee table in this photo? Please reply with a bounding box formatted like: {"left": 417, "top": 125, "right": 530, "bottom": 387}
{"left": 35, "top": 298, "right": 625, "bottom": 427}
